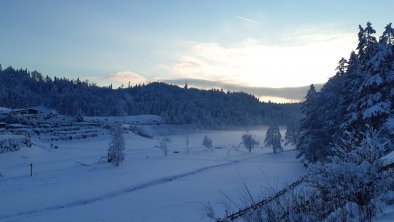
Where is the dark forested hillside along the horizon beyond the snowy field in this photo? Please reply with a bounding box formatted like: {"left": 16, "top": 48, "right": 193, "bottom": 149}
{"left": 0, "top": 66, "right": 299, "bottom": 127}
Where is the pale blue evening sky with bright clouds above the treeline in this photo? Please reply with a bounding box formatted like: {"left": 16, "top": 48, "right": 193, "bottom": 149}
{"left": 0, "top": 0, "right": 394, "bottom": 101}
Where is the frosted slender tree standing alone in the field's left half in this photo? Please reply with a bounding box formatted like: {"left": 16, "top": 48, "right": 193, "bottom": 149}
{"left": 107, "top": 124, "right": 125, "bottom": 166}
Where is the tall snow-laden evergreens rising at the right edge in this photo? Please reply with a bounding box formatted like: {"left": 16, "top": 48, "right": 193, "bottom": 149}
{"left": 297, "top": 22, "right": 394, "bottom": 162}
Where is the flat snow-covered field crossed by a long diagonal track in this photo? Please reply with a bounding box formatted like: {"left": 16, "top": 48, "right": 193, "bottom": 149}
{"left": 0, "top": 126, "right": 305, "bottom": 222}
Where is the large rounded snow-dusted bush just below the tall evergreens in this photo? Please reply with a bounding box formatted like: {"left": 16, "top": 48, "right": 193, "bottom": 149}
{"left": 307, "top": 133, "right": 394, "bottom": 221}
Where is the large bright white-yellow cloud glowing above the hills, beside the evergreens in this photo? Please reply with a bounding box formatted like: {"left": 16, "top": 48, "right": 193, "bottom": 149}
{"left": 161, "top": 34, "right": 356, "bottom": 87}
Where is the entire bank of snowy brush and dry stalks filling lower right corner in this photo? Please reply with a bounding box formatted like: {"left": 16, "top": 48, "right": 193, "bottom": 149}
{"left": 219, "top": 133, "right": 394, "bottom": 222}
